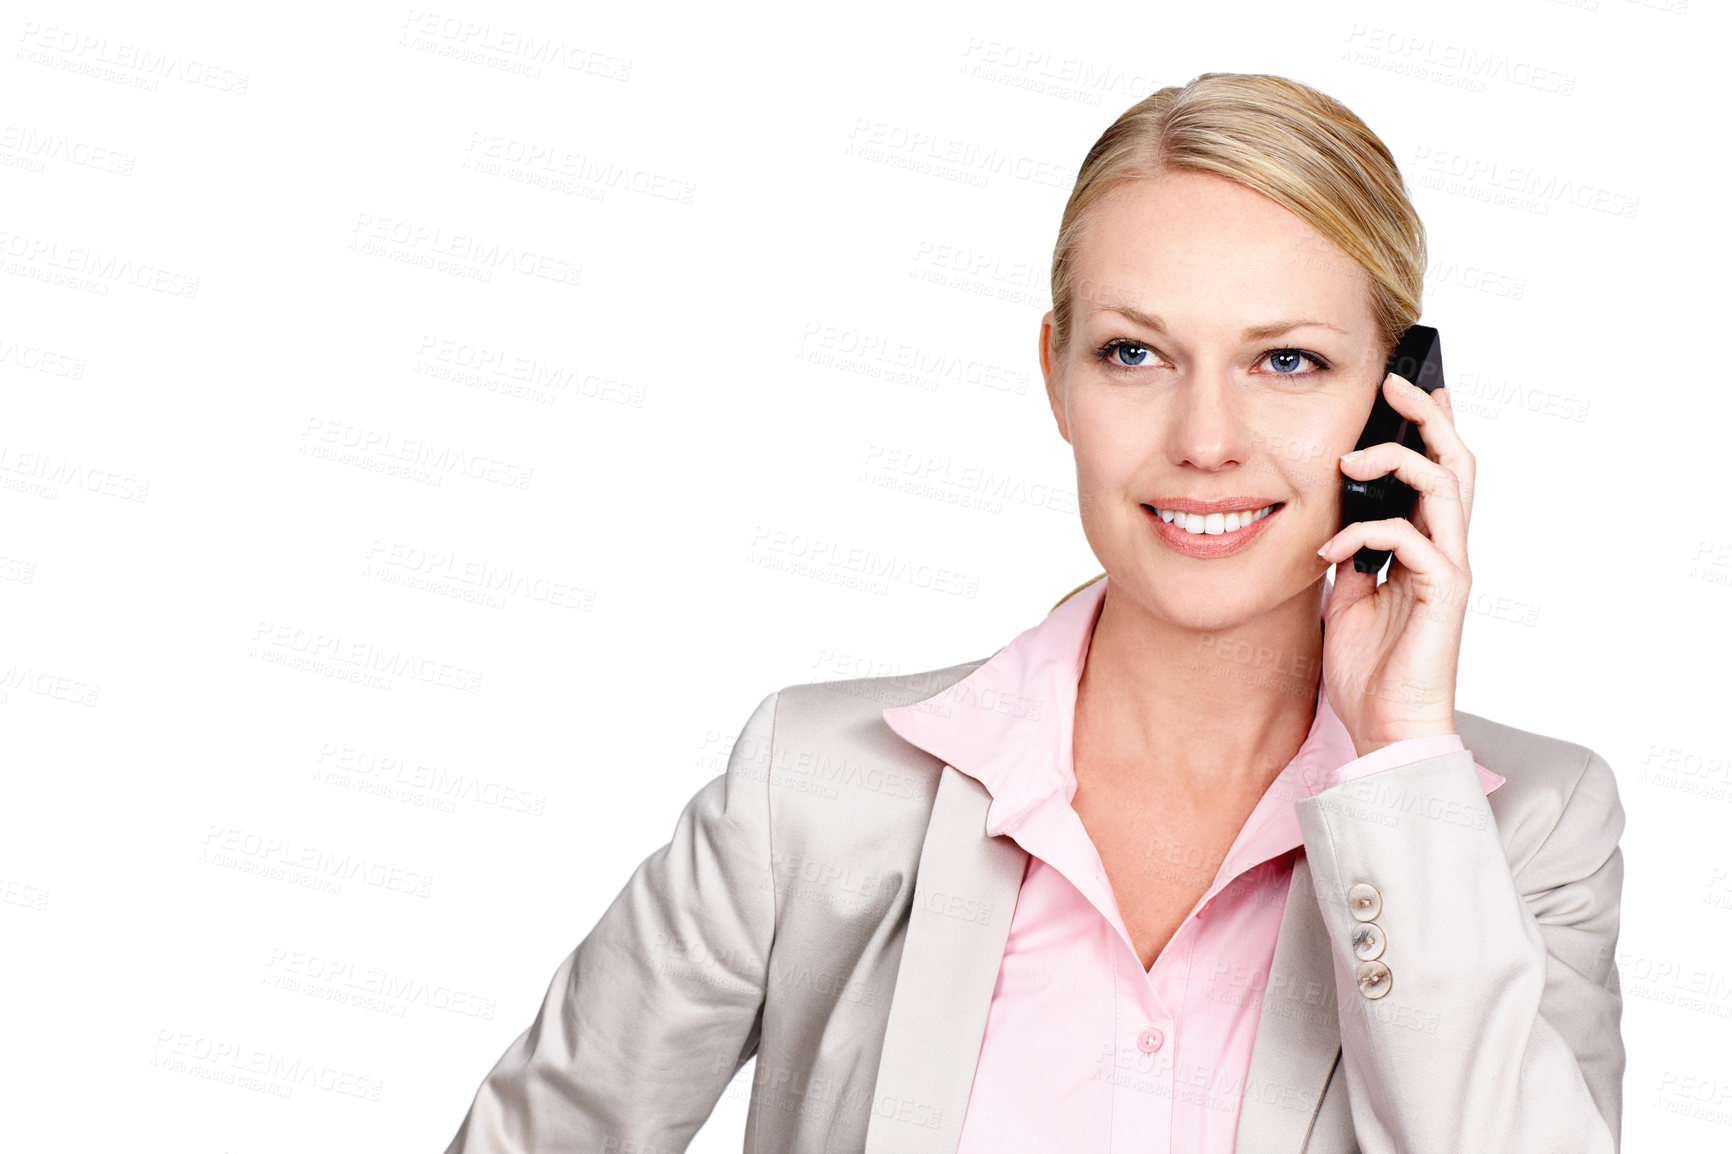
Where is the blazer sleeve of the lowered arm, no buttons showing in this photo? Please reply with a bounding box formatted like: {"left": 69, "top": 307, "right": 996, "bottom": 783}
{"left": 447, "top": 693, "right": 778, "bottom": 1154}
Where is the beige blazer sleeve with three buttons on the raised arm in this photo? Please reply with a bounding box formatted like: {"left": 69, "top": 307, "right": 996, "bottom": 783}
{"left": 1294, "top": 750, "right": 1625, "bottom": 1154}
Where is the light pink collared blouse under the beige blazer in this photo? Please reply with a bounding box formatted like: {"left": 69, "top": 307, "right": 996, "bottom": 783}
{"left": 883, "top": 577, "right": 1503, "bottom": 1154}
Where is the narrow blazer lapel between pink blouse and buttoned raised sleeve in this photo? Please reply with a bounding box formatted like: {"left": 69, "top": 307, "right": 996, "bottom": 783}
{"left": 1233, "top": 853, "right": 1341, "bottom": 1154}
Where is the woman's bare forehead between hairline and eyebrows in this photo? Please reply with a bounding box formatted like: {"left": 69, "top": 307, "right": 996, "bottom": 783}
{"left": 1072, "top": 172, "right": 1372, "bottom": 327}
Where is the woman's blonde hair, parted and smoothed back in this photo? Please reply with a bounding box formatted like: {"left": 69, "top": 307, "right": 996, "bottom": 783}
{"left": 1051, "top": 73, "right": 1425, "bottom": 355}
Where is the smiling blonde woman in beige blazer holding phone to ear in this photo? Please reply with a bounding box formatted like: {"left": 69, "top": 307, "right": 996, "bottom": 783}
{"left": 450, "top": 75, "right": 1623, "bottom": 1154}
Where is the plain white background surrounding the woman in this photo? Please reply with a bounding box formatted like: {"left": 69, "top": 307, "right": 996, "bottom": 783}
{"left": 0, "top": 0, "right": 1732, "bottom": 1152}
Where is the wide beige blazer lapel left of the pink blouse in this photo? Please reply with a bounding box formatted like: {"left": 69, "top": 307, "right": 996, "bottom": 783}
{"left": 866, "top": 766, "right": 1029, "bottom": 1154}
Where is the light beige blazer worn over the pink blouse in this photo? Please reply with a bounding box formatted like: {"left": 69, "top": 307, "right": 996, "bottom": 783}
{"left": 449, "top": 658, "right": 1625, "bottom": 1154}
